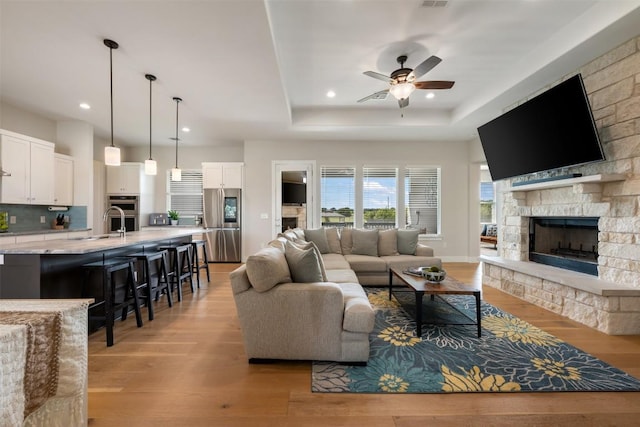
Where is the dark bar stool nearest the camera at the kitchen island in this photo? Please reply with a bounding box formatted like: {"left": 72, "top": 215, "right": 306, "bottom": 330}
{"left": 83, "top": 257, "right": 142, "bottom": 347}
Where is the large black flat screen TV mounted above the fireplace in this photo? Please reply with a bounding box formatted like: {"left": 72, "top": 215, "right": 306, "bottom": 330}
{"left": 478, "top": 74, "right": 604, "bottom": 181}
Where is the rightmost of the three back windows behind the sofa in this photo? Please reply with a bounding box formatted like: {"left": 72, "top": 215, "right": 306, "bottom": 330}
{"left": 404, "top": 166, "right": 440, "bottom": 234}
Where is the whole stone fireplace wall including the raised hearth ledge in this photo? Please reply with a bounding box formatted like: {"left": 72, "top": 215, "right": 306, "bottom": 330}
{"left": 484, "top": 36, "right": 640, "bottom": 334}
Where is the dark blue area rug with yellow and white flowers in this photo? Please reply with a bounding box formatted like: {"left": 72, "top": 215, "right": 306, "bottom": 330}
{"left": 311, "top": 289, "right": 640, "bottom": 393}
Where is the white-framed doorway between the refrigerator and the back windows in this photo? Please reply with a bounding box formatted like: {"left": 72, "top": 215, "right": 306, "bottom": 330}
{"left": 272, "top": 161, "right": 315, "bottom": 237}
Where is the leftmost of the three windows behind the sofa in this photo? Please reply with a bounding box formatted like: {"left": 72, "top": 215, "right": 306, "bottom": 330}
{"left": 320, "top": 166, "right": 356, "bottom": 228}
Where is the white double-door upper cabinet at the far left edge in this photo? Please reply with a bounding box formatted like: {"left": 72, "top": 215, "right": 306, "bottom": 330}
{"left": 0, "top": 131, "right": 54, "bottom": 205}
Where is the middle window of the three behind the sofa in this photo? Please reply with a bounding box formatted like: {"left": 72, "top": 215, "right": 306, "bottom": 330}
{"left": 362, "top": 166, "right": 398, "bottom": 228}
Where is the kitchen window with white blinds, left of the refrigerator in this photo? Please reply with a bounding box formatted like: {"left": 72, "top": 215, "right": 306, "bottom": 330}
{"left": 167, "top": 169, "right": 203, "bottom": 218}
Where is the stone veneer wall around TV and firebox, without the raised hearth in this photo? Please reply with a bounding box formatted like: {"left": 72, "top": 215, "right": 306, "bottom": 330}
{"left": 499, "top": 36, "right": 640, "bottom": 288}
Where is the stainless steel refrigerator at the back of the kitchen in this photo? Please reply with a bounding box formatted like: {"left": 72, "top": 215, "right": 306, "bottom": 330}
{"left": 203, "top": 188, "right": 242, "bottom": 262}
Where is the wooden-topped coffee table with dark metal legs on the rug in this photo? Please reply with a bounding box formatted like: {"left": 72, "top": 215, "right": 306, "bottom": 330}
{"left": 389, "top": 267, "right": 482, "bottom": 338}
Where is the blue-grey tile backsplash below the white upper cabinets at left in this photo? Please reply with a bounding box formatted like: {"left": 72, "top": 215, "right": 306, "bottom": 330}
{"left": 0, "top": 203, "right": 87, "bottom": 232}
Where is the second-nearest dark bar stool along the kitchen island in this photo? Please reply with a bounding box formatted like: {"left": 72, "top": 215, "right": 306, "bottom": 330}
{"left": 127, "top": 250, "right": 173, "bottom": 320}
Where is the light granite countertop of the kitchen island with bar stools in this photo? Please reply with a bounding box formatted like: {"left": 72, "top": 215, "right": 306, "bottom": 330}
{"left": 0, "top": 227, "right": 203, "bottom": 255}
